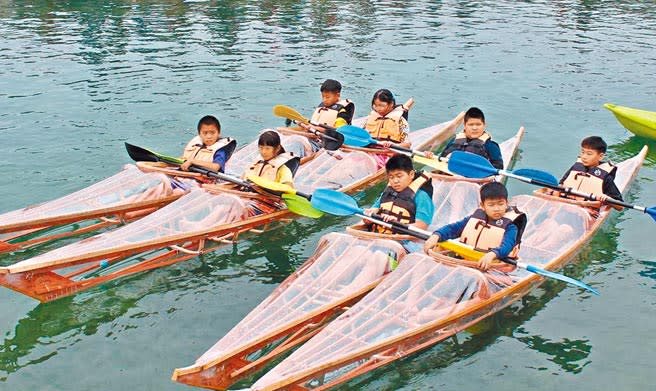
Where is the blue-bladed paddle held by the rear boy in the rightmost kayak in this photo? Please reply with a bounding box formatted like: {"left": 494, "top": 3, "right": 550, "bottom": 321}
{"left": 449, "top": 151, "right": 656, "bottom": 220}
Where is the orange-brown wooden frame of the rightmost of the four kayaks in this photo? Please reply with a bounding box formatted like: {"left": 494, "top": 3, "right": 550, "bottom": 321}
{"left": 249, "top": 146, "right": 647, "bottom": 391}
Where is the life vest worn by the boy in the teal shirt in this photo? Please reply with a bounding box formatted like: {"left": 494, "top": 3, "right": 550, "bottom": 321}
{"left": 372, "top": 173, "right": 433, "bottom": 233}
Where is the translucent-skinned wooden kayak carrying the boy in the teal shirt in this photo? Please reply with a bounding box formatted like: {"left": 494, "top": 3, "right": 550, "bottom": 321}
{"left": 172, "top": 128, "right": 524, "bottom": 389}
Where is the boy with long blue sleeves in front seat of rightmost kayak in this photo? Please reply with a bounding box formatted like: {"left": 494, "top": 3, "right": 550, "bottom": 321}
{"left": 424, "top": 182, "right": 526, "bottom": 271}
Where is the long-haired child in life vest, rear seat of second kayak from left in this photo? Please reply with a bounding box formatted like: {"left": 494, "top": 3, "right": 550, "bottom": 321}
{"left": 364, "top": 88, "right": 411, "bottom": 148}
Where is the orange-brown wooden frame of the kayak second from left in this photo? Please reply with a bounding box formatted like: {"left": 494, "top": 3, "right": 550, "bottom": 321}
{"left": 0, "top": 112, "right": 464, "bottom": 302}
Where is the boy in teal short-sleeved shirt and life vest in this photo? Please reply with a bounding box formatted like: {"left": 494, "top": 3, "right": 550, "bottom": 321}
{"left": 365, "top": 155, "right": 435, "bottom": 233}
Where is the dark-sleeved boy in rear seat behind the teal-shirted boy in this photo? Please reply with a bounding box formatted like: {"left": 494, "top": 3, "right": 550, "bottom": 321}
{"left": 440, "top": 107, "right": 503, "bottom": 170}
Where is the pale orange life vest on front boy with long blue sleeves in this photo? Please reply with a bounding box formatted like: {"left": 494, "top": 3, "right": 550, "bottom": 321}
{"left": 460, "top": 206, "right": 526, "bottom": 258}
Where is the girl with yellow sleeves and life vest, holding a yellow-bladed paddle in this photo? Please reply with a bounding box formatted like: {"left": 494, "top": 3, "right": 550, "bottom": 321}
{"left": 244, "top": 130, "right": 301, "bottom": 187}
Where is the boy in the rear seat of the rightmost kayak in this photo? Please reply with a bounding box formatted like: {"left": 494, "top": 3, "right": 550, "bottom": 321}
{"left": 560, "top": 136, "right": 623, "bottom": 210}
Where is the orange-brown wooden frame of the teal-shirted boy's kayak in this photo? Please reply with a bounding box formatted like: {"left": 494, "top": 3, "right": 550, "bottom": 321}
{"left": 171, "top": 127, "right": 524, "bottom": 390}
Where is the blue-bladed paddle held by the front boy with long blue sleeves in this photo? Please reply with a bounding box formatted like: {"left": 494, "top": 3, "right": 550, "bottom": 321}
{"left": 311, "top": 189, "right": 599, "bottom": 295}
